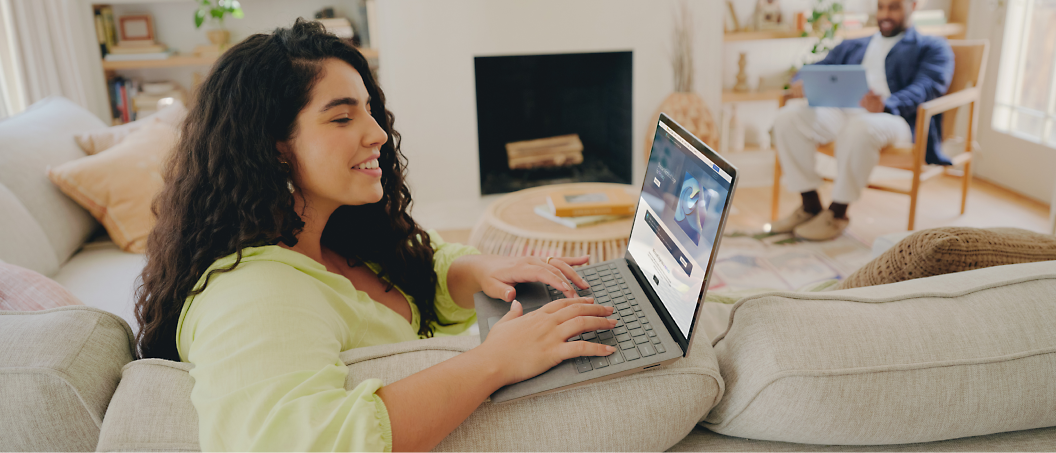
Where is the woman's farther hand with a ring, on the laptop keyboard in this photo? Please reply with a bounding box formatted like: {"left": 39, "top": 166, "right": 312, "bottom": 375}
{"left": 476, "top": 256, "right": 590, "bottom": 302}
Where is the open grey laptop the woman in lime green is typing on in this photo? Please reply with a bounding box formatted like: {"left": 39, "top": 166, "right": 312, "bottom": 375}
{"left": 474, "top": 114, "right": 737, "bottom": 402}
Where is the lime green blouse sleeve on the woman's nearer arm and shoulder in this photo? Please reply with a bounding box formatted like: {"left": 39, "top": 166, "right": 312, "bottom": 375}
{"left": 180, "top": 262, "right": 392, "bottom": 453}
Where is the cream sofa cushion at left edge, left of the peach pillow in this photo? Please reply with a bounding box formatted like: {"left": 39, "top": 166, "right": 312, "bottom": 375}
{"left": 0, "top": 183, "right": 59, "bottom": 276}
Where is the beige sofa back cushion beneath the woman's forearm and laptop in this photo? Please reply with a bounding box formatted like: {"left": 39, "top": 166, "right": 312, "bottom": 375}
{"left": 97, "top": 336, "right": 722, "bottom": 452}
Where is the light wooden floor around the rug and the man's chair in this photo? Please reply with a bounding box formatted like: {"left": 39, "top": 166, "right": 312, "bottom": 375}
{"left": 439, "top": 175, "right": 1050, "bottom": 249}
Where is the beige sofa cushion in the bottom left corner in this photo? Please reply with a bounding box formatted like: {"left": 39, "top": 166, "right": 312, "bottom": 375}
{"left": 0, "top": 305, "right": 132, "bottom": 452}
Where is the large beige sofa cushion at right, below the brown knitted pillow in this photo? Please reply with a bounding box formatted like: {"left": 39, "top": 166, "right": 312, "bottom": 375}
{"left": 704, "top": 261, "right": 1056, "bottom": 445}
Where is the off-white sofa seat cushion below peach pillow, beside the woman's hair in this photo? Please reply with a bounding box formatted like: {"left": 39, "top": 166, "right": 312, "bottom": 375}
{"left": 52, "top": 240, "right": 147, "bottom": 333}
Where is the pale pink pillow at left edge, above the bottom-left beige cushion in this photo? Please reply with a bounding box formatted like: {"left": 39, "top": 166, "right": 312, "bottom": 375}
{"left": 0, "top": 263, "right": 83, "bottom": 312}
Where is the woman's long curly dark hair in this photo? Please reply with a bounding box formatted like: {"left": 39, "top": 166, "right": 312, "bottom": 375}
{"left": 135, "top": 19, "right": 438, "bottom": 360}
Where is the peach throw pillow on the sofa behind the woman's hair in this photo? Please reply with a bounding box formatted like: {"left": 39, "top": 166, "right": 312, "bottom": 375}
{"left": 48, "top": 122, "right": 176, "bottom": 253}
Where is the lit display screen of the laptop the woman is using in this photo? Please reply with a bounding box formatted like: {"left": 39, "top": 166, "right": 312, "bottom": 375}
{"left": 627, "top": 122, "right": 731, "bottom": 338}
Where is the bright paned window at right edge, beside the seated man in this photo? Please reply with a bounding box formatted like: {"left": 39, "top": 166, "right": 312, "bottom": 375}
{"left": 993, "top": 0, "right": 1056, "bottom": 148}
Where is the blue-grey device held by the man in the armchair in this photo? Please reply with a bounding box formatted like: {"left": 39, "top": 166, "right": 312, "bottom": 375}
{"left": 799, "top": 64, "right": 869, "bottom": 109}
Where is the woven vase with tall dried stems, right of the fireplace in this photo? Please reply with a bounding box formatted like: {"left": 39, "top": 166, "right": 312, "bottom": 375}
{"left": 645, "top": 0, "right": 718, "bottom": 161}
